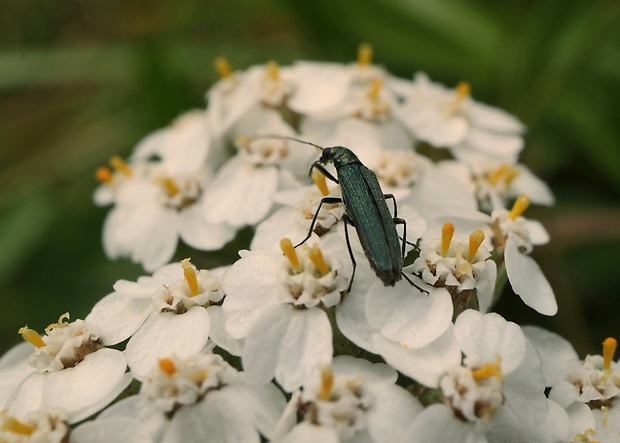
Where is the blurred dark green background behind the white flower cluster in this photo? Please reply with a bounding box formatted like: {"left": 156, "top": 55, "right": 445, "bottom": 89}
{"left": 0, "top": 0, "right": 620, "bottom": 354}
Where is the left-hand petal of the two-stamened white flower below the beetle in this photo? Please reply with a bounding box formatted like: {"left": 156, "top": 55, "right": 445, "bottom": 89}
{"left": 222, "top": 254, "right": 280, "bottom": 339}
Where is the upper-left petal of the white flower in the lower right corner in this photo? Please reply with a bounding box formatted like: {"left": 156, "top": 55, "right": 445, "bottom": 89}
{"left": 521, "top": 326, "right": 579, "bottom": 387}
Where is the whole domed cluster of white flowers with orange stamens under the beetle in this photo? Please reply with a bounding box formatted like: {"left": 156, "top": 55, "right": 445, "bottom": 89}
{"left": 0, "top": 45, "right": 620, "bottom": 443}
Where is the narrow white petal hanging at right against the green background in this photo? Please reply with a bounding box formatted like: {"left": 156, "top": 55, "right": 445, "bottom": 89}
{"left": 504, "top": 237, "right": 558, "bottom": 315}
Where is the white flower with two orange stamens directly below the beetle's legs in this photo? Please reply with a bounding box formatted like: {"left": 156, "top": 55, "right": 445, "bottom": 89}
{"left": 223, "top": 233, "right": 352, "bottom": 392}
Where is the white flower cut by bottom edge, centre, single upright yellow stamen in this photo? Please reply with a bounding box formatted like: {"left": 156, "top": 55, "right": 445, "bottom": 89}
{"left": 273, "top": 356, "right": 422, "bottom": 443}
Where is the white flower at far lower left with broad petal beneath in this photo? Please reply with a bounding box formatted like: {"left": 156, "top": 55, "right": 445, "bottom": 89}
{"left": 6, "top": 314, "right": 132, "bottom": 423}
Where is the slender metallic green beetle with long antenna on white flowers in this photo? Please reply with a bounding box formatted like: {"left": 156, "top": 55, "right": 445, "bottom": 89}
{"left": 243, "top": 135, "right": 413, "bottom": 292}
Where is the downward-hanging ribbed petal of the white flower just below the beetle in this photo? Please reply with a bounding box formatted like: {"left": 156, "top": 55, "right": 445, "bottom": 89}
{"left": 242, "top": 305, "right": 333, "bottom": 392}
